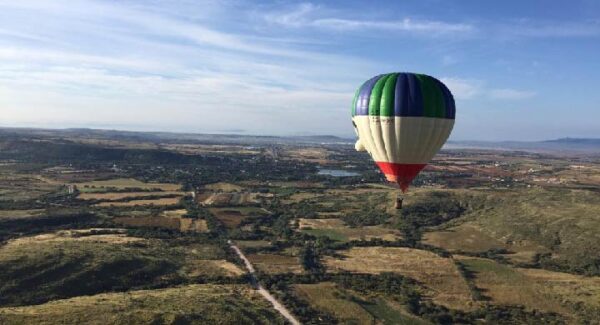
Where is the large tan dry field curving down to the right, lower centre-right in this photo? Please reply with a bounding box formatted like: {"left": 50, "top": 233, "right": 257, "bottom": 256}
{"left": 324, "top": 247, "right": 476, "bottom": 310}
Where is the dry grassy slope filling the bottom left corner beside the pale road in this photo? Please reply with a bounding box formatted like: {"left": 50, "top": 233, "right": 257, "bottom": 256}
{"left": 0, "top": 284, "right": 283, "bottom": 324}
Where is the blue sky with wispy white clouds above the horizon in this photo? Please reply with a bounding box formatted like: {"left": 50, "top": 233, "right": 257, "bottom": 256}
{"left": 0, "top": 0, "right": 600, "bottom": 141}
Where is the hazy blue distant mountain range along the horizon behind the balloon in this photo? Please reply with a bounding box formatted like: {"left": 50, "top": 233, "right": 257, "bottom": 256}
{"left": 0, "top": 127, "right": 600, "bottom": 154}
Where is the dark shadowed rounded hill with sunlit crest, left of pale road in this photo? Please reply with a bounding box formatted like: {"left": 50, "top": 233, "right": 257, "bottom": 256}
{"left": 0, "top": 229, "right": 230, "bottom": 306}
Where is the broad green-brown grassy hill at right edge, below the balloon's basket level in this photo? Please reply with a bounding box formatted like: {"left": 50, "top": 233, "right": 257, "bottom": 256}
{"left": 425, "top": 188, "right": 600, "bottom": 275}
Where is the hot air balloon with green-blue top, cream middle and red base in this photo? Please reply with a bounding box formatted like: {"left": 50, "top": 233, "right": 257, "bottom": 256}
{"left": 352, "top": 73, "right": 456, "bottom": 208}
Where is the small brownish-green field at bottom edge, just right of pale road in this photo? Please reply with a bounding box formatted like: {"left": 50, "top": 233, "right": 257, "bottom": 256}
{"left": 294, "top": 282, "right": 375, "bottom": 324}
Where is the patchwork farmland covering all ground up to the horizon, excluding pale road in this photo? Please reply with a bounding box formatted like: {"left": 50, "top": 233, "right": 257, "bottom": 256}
{"left": 0, "top": 128, "right": 600, "bottom": 324}
